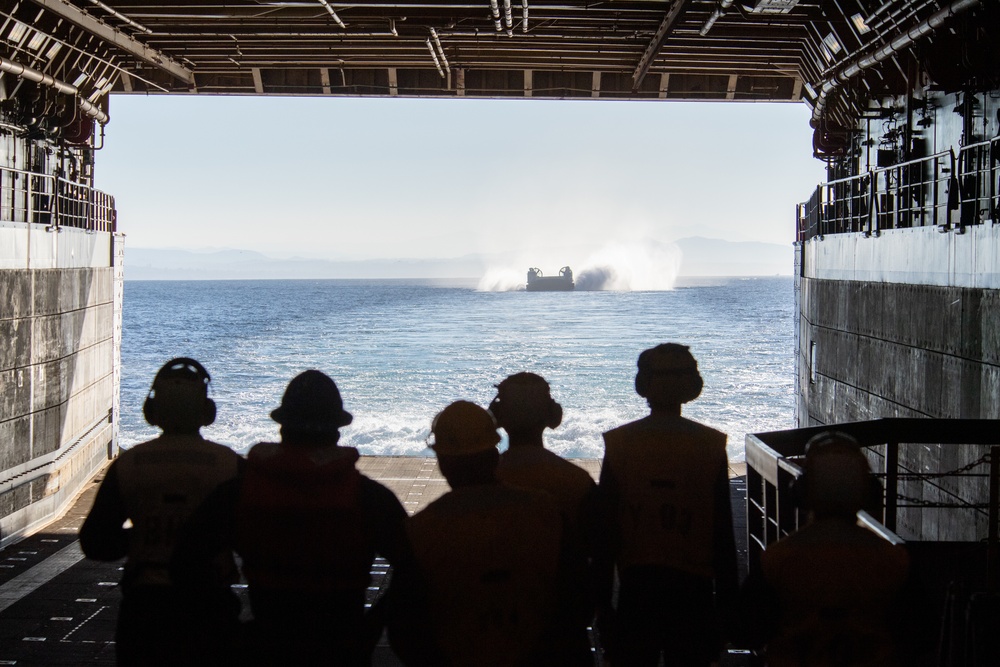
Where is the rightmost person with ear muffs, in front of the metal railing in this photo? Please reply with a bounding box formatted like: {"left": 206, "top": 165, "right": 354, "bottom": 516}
{"left": 744, "top": 432, "right": 909, "bottom": 667}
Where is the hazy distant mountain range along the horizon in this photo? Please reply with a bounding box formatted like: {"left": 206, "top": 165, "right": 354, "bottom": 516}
{"left": 125, "top": 236, "right": 792, "bottom": 280}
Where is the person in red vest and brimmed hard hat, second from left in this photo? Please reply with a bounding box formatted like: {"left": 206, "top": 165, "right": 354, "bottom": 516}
{"left": 236, "top": 370, "right": 407, "bottom": 665}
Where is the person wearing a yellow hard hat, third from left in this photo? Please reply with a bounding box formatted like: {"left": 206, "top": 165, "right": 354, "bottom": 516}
{"left": 390, "top": 401, "right": 562, "bottom": 666}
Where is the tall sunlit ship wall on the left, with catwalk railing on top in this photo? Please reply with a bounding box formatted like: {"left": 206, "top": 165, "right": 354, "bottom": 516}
{"left": 0, "top": 125, "right": 124, "bottom": 546}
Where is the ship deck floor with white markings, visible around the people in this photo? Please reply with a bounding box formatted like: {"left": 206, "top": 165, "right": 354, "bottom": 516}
{"left": 0, "top": 456, "right": 746, "bottom": 665}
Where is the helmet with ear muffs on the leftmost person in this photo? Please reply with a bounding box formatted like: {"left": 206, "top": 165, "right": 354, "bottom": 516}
{"left": 142, "top": 357, "right": 216, "bottom": 431}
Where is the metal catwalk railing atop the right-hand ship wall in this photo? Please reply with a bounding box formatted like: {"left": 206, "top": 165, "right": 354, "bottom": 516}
{"left": 797, "top": 137, "right": 1000, "bottom": 241}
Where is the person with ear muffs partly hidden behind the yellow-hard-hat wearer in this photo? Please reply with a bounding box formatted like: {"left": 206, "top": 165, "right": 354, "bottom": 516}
{"left": 489, "top": 373, "right": 596, "bottom": 665}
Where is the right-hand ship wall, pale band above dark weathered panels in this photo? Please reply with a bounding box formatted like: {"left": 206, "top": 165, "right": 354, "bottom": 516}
{"left": 796, "top": 224, "right": 1000, "bottom": 540}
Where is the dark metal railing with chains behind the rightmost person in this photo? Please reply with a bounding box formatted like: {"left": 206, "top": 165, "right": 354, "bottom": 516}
{"left": 746, "top": 419, "right": 1000, "bottom": 590}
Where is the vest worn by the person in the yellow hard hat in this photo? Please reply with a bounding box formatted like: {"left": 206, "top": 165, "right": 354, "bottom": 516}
{"left": 407, "top": 485, "right": 561, "bottom": 666}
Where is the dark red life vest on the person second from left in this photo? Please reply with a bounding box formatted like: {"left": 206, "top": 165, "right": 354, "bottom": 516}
{"left": 236, "top": 443, "right": 374, "bottom": 594}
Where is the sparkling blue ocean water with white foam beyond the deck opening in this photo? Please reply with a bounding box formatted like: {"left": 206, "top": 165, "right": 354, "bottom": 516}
{"left": 121, "top": 277, "right": 794, "bottom": 460}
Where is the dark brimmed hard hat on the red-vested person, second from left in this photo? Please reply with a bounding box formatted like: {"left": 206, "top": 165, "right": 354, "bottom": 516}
{"left": 271, "top": 370, "right": 354, "bottom": 432}
